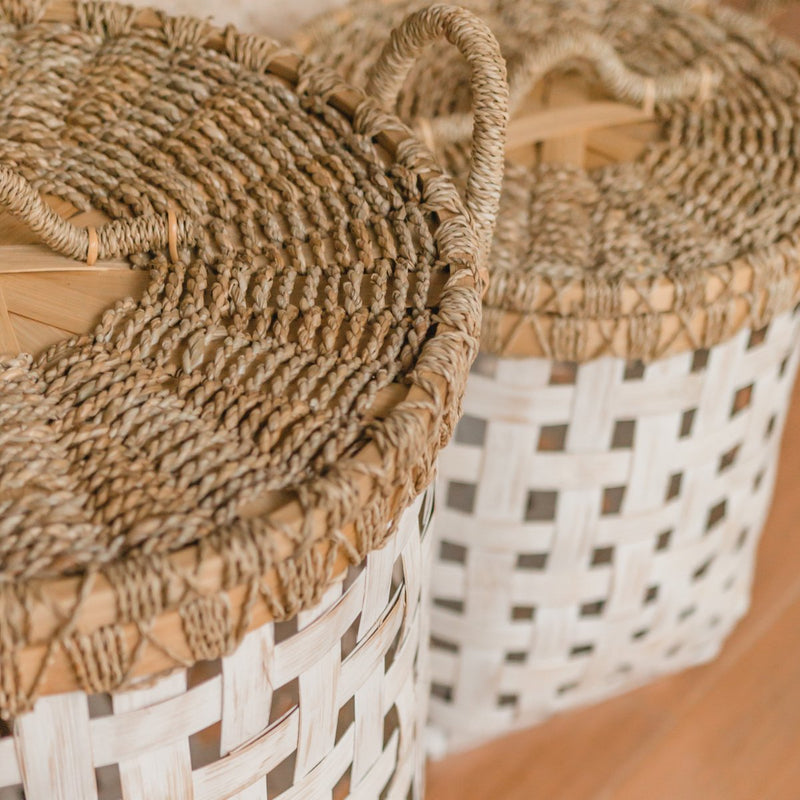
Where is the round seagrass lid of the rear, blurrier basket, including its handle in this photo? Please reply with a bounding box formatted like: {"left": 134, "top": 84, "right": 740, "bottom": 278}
{"left": 296, "top": 0, "right": 800, "bottom": 361}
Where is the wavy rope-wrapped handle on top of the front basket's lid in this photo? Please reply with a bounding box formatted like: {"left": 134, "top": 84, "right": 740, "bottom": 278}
{"left": 0, "top": 165, "right": 193, "bottom": 266}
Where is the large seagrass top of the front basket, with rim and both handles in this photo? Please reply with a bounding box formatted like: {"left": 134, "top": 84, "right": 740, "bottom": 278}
{"left": 0, "top": 0, "right": 507, "bottom": 714}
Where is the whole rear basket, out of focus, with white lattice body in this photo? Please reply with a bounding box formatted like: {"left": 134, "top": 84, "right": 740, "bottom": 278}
{"left": 298, "top": 0, "right": 800, "bottom": 751}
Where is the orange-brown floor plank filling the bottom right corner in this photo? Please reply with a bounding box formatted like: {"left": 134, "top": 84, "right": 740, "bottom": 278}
{"left": 609, "top": 589, "right": 800, "bottom": 800}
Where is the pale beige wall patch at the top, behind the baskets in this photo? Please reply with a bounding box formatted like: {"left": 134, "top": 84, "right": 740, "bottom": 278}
{"left": 129, "top": 0, "right": 346, "bottom": 39}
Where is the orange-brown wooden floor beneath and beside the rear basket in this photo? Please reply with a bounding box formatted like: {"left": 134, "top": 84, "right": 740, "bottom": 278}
{"left": 428, "top": 11, "right": 800, "bottom": 800}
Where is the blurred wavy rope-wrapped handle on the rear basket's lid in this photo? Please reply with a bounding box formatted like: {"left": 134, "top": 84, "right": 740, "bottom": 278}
{"left": 412, "top": 30, "right": 720, "bottom": 141}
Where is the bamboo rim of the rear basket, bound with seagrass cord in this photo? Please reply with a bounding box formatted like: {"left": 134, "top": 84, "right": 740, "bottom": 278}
{"left": 290, "top": 0, "right": 800, "bottom": 363}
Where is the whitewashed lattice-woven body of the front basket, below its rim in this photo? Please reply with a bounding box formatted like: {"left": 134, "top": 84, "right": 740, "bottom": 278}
{"left": 0, "top": 498, "right": 431, "bottom": 800}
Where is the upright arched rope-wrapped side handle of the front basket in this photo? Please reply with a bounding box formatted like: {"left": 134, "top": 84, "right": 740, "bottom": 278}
{"left": 367, "top": 5, "right": 508, "bottom": 262}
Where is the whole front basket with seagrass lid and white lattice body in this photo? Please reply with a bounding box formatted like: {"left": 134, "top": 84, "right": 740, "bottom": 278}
{"left": 0, "top": 0, "right": 507, "bottom": 800}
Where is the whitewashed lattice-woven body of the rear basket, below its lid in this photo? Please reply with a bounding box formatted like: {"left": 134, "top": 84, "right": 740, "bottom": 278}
{"left": 431, "top": 313, "right": 800, "bottom": 748}
